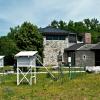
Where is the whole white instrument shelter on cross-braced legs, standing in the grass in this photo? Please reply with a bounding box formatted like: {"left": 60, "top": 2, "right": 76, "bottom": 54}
{"left": 15, "top": 51, "right": 37, "bottom": 85}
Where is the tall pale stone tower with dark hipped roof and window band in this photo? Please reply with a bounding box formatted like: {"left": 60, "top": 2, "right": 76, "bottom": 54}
{"left": 40, "top": 27, "right": 77, "bottom": 66}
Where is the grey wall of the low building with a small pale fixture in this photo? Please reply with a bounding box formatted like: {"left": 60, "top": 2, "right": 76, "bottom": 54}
{"left": 75, "top": 50, "right": 95, "bottom": 66}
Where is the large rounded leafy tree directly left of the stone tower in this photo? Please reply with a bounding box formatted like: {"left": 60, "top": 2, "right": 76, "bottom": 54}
{"left": 8, "top": 22, "right": 43, "bottom": 55}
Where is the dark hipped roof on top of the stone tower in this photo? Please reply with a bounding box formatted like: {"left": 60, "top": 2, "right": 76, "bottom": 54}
{"left": 39, "top": 27, "right": 69, "bottom": 35}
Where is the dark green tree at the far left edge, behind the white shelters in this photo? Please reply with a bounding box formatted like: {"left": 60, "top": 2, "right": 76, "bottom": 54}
{"left": 0, "top": 37, "right": 18, "bottom": 65}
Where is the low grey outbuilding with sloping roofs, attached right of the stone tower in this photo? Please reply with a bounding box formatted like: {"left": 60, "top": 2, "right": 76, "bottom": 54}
{"left": 65, "top": 43, "right": 97, "bottom": 66}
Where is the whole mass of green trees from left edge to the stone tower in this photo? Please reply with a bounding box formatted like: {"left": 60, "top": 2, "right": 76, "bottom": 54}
{"left": 0, "top": 22, "right": 43, "bottom": 65}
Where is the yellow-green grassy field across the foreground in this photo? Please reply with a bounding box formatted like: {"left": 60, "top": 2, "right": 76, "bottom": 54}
{"left": 0, "top": 73, "right": 100, "bottom": 100}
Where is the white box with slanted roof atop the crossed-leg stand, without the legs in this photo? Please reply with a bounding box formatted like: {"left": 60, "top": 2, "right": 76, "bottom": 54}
{"left": 15, "top": 51, "right": 37, "bottom": 67}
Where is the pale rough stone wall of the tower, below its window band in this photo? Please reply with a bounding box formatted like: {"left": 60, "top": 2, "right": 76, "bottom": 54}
{"left": 43, "top": 37, "right": 69, "bottom": 66}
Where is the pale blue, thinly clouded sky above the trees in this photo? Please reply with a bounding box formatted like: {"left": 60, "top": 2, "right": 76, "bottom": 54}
{"left": 0, "top": 0, "right": 100, "bottom": 36}
